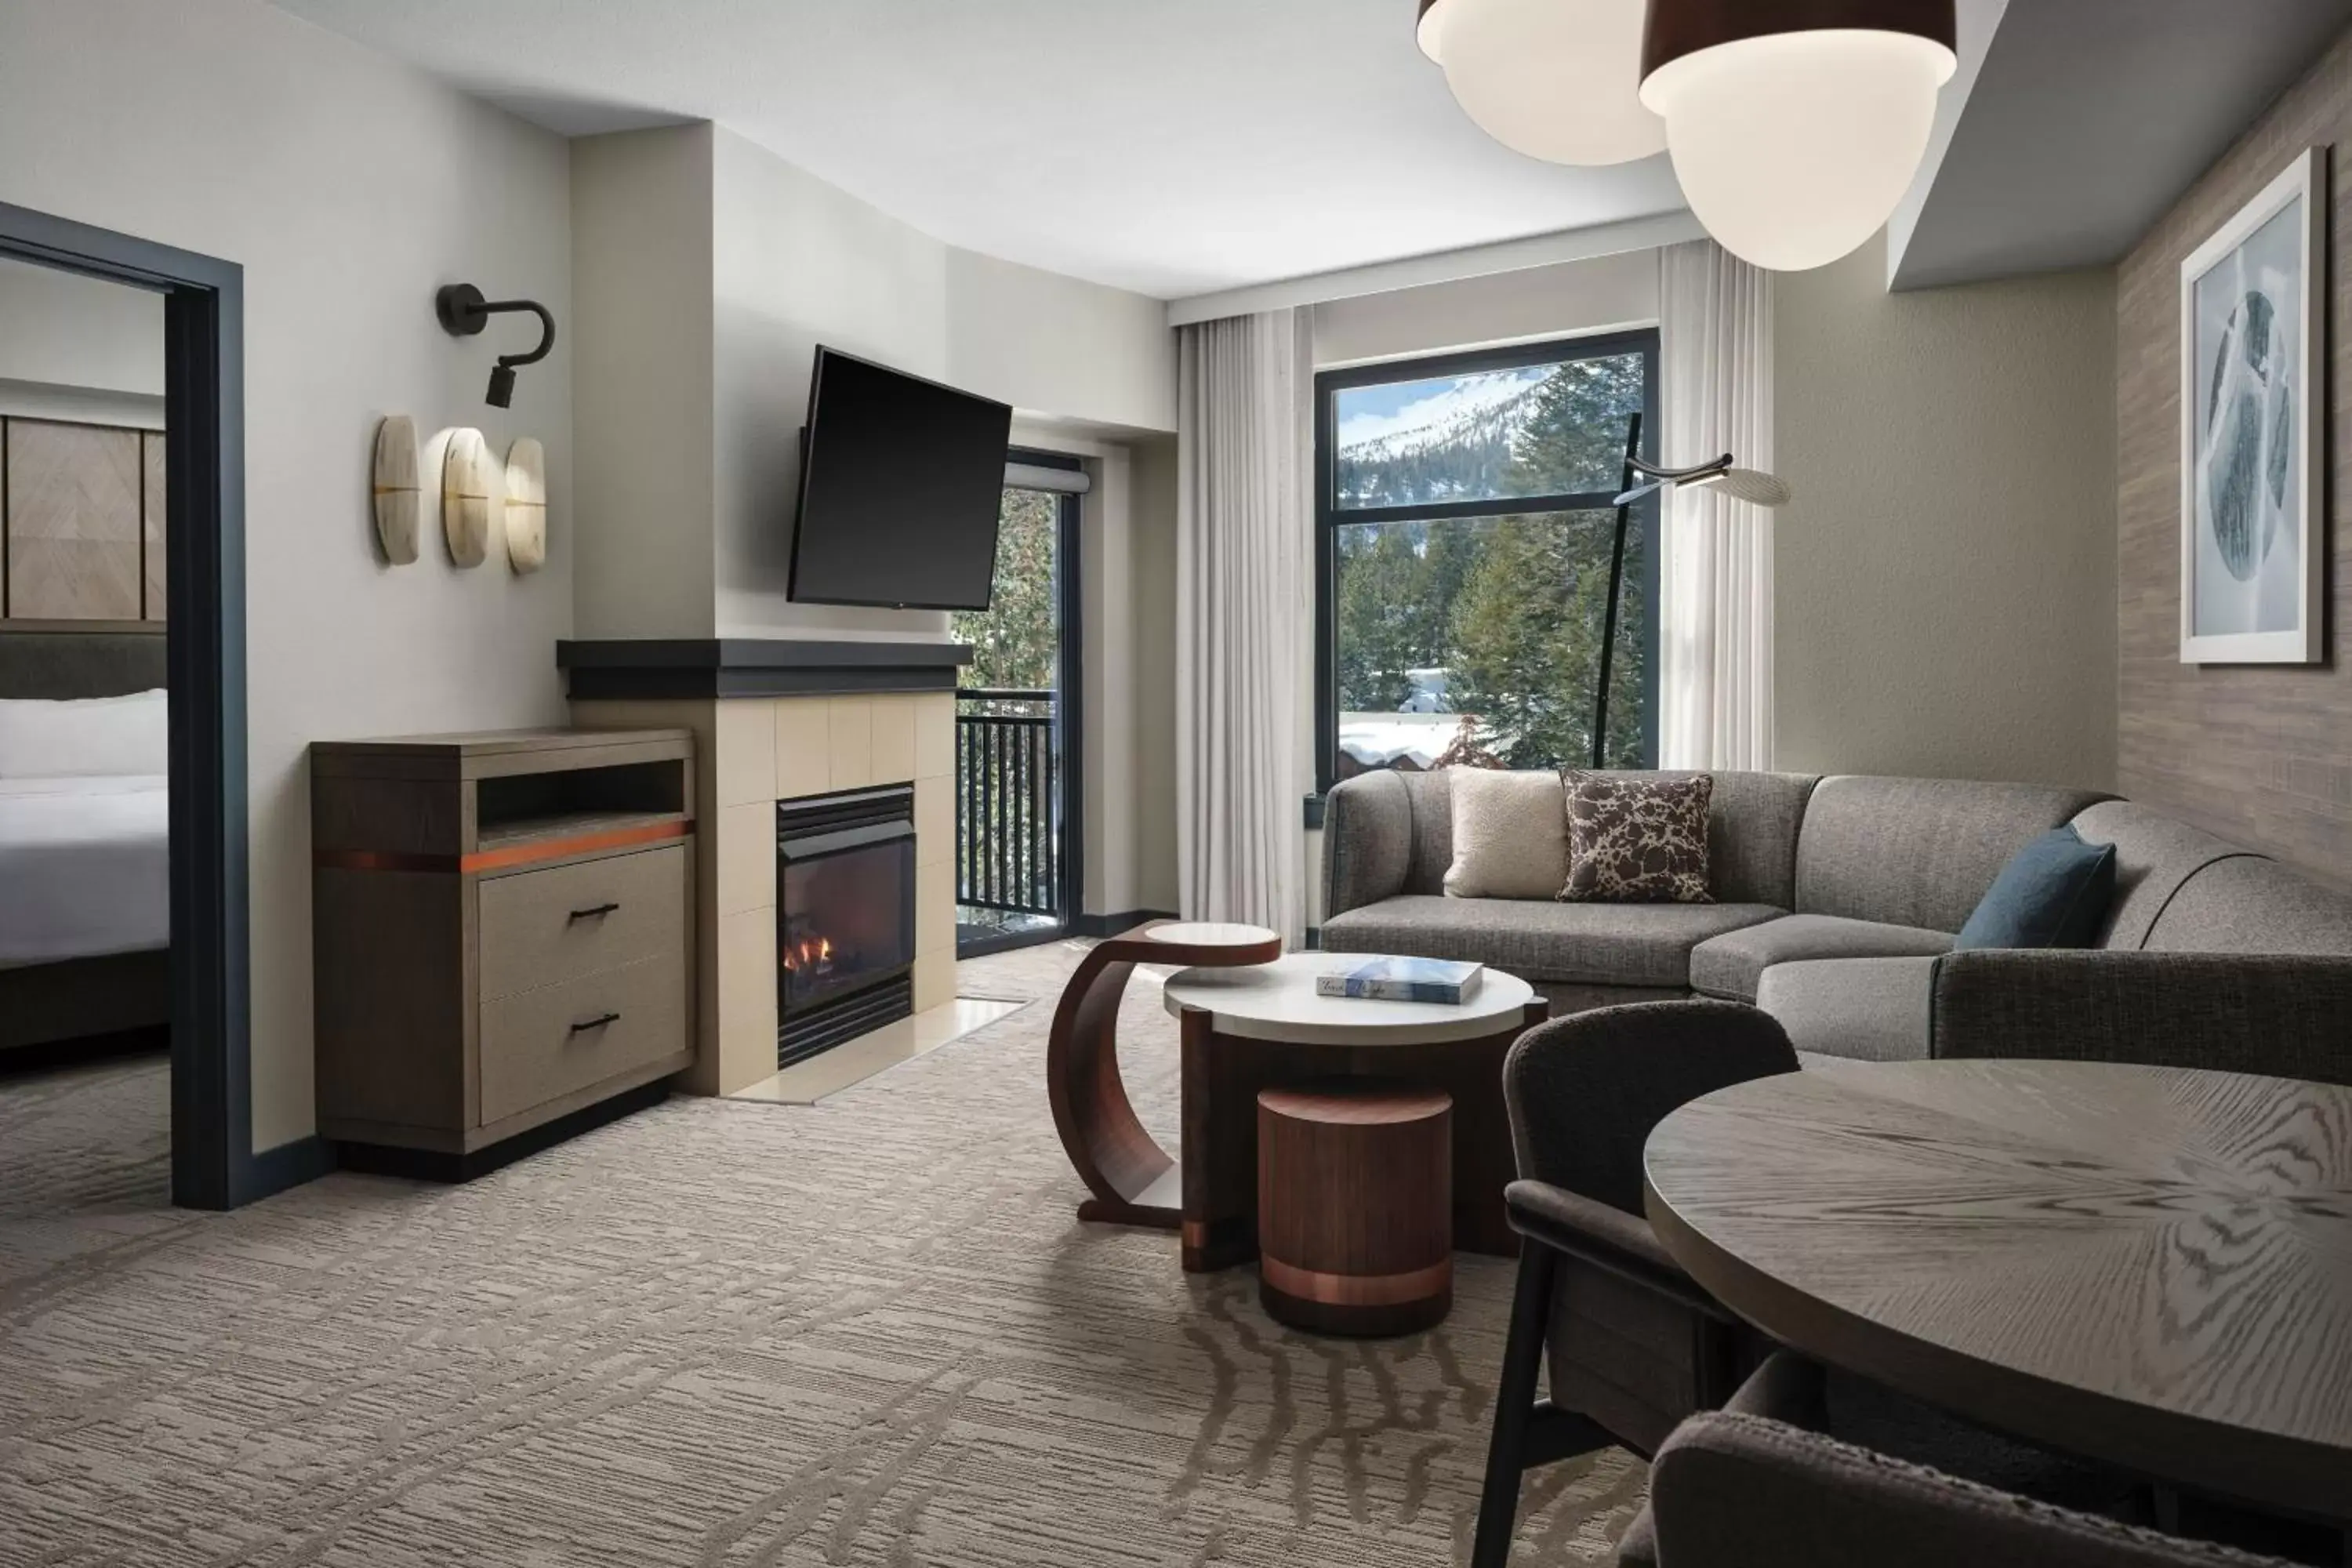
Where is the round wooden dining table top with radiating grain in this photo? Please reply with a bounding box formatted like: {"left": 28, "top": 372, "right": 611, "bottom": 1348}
{"left": 1644, "top": 1060, "right": 2352, "bottom": 1521}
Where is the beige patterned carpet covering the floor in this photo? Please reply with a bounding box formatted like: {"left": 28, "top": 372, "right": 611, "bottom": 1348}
{"left": 0, "top": 947, "right": 1642, "bottom": 1568}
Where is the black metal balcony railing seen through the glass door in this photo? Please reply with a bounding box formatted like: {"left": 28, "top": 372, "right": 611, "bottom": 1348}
{"left": 955, "top": 689, "right": 1063, "bottom": 916}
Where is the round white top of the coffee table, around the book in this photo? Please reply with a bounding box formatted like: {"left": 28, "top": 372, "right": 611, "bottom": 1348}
{"left": 1164, "top": 952, "right": 1536, "bottom": 1046}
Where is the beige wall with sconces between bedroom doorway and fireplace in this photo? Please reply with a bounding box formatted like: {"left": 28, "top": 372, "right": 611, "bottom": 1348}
{"left": 0, "top": 0, "right": 572, "bottom": 1147}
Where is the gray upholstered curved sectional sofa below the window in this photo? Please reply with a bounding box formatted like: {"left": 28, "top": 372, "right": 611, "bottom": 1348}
{"left": 1322, "top": 771, "right": 2352, "bottom": 1081}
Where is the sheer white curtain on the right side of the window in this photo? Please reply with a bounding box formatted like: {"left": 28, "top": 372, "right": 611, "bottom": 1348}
{"left": 1658, "top": 240, "right": 1773, "bottom": 769}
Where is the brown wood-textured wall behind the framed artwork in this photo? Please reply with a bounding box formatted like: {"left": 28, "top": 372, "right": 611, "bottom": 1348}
{"left": 2117, "top": 35, "right": 2352, "bottom": 884}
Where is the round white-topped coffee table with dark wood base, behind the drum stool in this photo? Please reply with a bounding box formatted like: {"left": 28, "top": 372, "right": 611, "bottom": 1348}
{"left": 1167, "top": 952, "right": 1548, "bottom": 1269}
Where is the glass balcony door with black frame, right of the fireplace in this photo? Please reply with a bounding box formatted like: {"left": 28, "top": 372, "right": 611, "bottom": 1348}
{"left": 953, "top": 449, "right": 1087, "bottom": 959}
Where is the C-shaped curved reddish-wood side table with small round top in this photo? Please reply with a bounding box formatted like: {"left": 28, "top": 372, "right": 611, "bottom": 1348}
{"left": 1044, "top": 919, "right": 1282, "bottom": 1229}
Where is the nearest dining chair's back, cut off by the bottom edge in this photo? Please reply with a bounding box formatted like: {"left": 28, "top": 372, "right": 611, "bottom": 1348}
{"left": 1618, "top": 1352, "right": 2291, "bottom": 1568}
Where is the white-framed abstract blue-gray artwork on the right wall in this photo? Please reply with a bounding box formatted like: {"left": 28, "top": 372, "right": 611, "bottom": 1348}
{"left": 2180, "top": 148, "right": 2328, "bottom": 666}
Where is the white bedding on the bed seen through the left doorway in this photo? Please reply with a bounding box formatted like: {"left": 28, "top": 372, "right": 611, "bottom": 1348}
{"left": 0, "top": 774, "right": 172, "bottom": 964}
